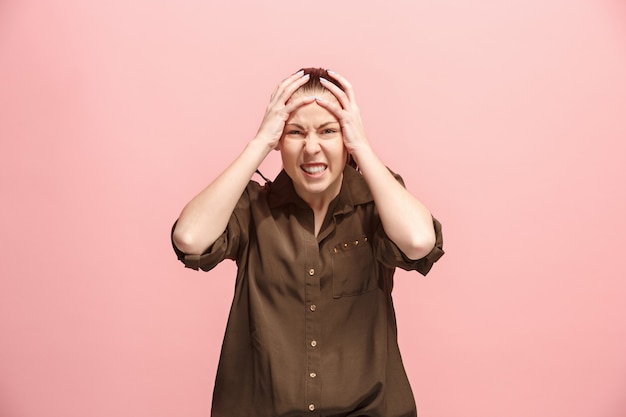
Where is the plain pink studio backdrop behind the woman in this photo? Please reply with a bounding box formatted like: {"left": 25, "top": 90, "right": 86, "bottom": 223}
{"left": 0, "top": 0, "right": 626, "bottom": 417}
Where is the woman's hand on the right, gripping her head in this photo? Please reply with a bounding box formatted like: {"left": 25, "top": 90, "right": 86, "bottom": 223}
{"left": 317, "top": 71, "right": 369, "bottom": 156}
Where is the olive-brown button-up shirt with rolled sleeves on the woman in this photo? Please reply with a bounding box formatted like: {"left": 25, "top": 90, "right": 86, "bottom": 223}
{"left": 174, "top": 166, "right": 443, "bottom": 417}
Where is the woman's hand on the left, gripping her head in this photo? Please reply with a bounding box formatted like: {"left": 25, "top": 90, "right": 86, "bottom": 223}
{"left": 255, "top": 70, "right": 315, "bottom": 149}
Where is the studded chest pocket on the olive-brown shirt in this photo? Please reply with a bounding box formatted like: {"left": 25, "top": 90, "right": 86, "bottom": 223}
{"left": 331, "top": 236, "right": 376, "bottom": 298}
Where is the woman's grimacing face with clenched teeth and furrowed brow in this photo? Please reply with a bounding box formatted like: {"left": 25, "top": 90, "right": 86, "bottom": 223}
{"left": 280, "top": 91, "right": 348, "bottom": 206}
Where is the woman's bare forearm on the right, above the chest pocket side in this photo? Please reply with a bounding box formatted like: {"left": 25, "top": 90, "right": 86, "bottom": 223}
{"left": 353, "top": 143, "right": 436, "bottom": 259}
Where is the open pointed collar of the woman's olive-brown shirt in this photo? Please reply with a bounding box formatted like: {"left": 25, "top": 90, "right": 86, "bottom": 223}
{"left": 268, "top": 165, "right": 374, "bottom": 214}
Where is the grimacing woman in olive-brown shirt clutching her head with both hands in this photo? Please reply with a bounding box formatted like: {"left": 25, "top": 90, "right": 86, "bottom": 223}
{"left": 172, "top": 68, "right": 443, "bottom": 417}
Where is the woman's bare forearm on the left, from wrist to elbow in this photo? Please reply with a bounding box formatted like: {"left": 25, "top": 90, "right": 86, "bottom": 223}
{"left": 173, "top": 140, "right": 271, "bottom": 254}
